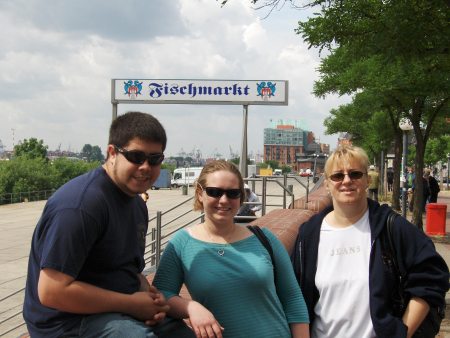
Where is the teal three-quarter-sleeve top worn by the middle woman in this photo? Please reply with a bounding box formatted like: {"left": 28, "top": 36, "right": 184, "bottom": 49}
{"left": 153, "top": 229, "right": 309, "bottom": 338}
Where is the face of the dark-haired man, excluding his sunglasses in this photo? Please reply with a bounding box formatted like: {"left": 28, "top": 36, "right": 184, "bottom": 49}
{"left": 107, "top": 138, "right": 162, "bottom": 196}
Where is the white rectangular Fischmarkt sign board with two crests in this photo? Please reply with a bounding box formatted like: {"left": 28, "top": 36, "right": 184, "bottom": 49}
{"left": 111, "top": 78, "right": 288, "bottom": 105}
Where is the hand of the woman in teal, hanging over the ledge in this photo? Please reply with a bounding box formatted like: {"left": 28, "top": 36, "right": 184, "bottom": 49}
{"left": 187, "top": 301, "right": 224, "bottom": 338}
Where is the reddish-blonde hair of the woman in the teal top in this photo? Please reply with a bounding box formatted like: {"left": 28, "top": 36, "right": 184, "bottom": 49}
{"left": 194, "top": 160, "right": 245, "bottom": 211}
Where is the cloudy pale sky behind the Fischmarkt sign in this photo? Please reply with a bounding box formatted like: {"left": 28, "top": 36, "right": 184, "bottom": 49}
{"left": 0, "top": 0, "right": 348, "bottom": 157}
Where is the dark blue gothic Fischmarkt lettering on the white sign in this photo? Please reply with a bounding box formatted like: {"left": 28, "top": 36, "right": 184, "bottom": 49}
{"left": 148, "top": 82, "right": 250, "bottom": 99}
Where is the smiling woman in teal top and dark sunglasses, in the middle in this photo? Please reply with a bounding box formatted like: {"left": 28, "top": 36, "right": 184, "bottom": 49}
{"left": 154, "top": 161, "right": 309, "bottom": 338}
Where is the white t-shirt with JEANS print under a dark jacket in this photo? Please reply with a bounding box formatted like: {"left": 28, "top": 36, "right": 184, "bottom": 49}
{"left": 311, "top": 211, "right": 376, "bottom": 338}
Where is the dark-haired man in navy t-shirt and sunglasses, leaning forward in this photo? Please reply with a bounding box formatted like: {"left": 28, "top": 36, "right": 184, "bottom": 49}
{"left": 23, "top": 112, "right": 192, "bottom": 338}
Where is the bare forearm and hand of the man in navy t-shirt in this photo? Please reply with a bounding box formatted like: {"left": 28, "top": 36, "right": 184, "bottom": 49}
{"left": 38, "top": 268, "right": 169, "bottom": 321}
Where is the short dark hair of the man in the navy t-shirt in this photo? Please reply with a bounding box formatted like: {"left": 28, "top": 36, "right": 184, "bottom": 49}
{"left": 108, "top": 112, "right": 167, "bottom": 151}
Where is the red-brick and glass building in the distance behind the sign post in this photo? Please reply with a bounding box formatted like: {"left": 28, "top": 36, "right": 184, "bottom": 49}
{"left": 264, "top": 121, "right": 330, "bottom": 171}
